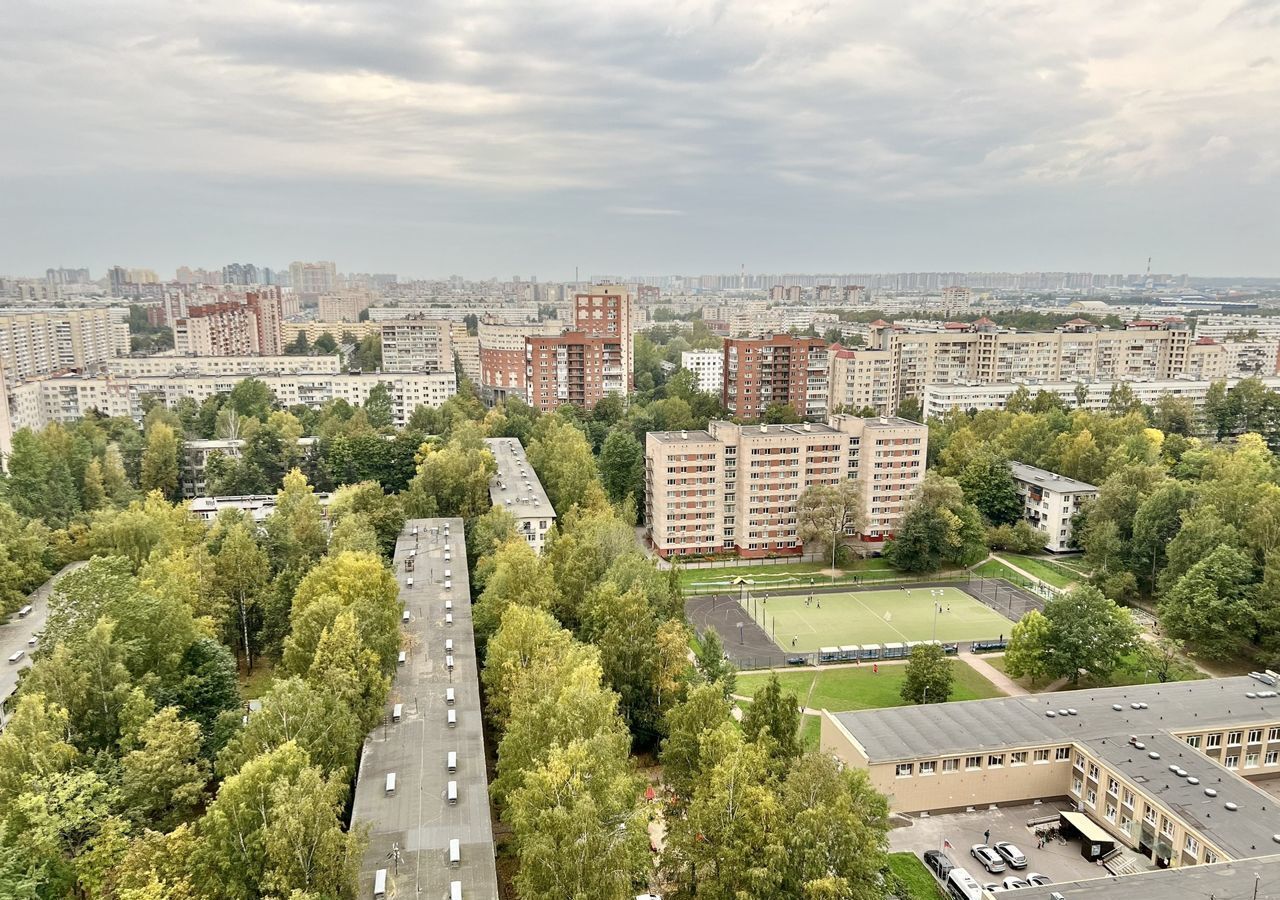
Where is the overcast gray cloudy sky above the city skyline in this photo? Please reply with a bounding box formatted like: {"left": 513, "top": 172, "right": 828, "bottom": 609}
{"left": 0, "top": 0, "right": 1280, "bottom": 278}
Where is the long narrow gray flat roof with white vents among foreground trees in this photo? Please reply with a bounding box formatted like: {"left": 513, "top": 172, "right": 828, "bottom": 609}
{"left": 352, "top": 518, "right": 498, "bottom": 900}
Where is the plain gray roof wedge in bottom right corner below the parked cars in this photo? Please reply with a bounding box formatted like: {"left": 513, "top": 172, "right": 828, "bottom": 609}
{"left": 1013, "top": 856, "right": 1280, "bottom": 900}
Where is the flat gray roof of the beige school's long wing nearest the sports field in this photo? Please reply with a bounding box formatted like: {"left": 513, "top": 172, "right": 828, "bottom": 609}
{"left": 835, "top": 675, "right": 1280, "bottom": 763}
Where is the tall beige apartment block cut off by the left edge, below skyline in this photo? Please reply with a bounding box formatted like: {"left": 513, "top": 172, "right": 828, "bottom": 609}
{"left": 0, "top": 307, "right": 129, "bottom": 384}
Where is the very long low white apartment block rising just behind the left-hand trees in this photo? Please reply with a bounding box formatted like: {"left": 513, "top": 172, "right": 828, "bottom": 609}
{"left": 9, "top": 369, "right": 457, "bottom": 430}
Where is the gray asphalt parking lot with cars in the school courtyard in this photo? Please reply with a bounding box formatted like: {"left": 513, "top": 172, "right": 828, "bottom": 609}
{"left": 888, "top": 804, "right": 1107, "bottom": 885}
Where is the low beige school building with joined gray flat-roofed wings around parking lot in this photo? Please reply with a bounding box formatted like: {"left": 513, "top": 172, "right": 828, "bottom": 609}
{"left": 820, "top": 675, "right": 1280, "bottom": 875}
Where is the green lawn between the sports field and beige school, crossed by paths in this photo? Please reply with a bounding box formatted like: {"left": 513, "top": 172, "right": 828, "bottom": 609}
{"left": 735, "top": 659, "right": 1004, "bottom": 713}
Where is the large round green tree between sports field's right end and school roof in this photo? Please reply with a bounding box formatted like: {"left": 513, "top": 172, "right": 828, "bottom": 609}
{"left": 1044, "top": 585, "right": 1138, "bottom": 684}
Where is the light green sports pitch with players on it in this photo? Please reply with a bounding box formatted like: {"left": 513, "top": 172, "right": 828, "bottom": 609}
{"left": 746, "top": 586, "right": 1012, "bottom": 653}
